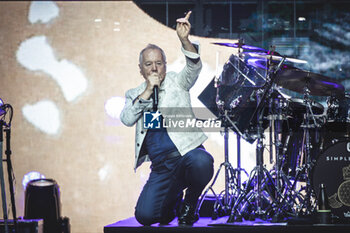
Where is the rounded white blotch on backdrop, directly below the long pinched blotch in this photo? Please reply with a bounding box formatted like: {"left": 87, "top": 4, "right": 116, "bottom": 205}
{"left": 22, "top": 100, "right": 61, "bottom": 135}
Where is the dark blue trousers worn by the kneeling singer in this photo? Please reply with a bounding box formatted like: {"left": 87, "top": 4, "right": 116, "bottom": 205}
{"left": 135, "top": 148, "right": 214, "bottom": 225}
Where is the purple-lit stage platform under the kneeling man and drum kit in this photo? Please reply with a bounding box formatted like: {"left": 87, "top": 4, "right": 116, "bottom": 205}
{"left": 104, "top": 216, "right": 350, "bottom": 233}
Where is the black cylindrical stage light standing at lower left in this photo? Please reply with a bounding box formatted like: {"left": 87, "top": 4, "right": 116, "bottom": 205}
{"left": 24, "top": 179, "right": 69, "bottom": 233}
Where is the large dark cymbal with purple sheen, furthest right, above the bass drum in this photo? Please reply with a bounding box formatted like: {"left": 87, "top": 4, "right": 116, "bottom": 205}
{"left": 276, "top": 68, "right": 345, "bottom": 96}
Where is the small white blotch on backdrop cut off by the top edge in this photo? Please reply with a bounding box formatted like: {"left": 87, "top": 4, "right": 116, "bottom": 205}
{"left": 28, "top": 1, "right": 59, "bottom": 24}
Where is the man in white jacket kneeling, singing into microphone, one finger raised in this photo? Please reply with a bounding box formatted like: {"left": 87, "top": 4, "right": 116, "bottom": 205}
{"left": 120, "top": 12, "right": 213, "bottom": 225}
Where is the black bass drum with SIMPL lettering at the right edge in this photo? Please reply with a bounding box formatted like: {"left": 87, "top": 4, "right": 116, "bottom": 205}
{"left": 312, "top": 140, "right": 350, "bottom": 222}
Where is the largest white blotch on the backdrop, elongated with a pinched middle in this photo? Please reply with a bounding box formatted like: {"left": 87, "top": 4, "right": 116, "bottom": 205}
{"left": 16, "top": 36, "right": 87, "bottom": 101}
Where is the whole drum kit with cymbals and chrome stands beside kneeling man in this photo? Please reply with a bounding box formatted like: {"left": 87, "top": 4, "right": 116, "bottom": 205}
{"left": 198, "top": 41, "right": 350, "bottom": 223}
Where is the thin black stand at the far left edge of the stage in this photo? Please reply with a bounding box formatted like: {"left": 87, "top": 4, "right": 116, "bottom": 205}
{"left": 0, "top": 104, "right": 18, "bottom": 233}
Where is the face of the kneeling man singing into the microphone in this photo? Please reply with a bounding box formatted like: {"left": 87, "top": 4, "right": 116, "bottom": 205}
{"left": 139, "top": 49, "right": 166, "bottom": 82}
